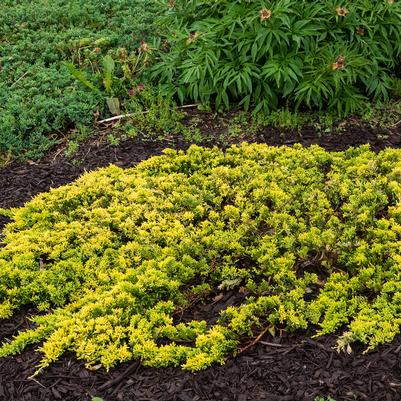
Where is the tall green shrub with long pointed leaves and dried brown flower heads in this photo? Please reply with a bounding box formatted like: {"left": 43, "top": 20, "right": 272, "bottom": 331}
{"left": 152, "top": 0, "right": 401, "bottom": 115}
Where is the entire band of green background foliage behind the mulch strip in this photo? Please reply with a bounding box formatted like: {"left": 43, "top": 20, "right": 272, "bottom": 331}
{"left": 0, "top": 0, "right": 401, "bottom": 162}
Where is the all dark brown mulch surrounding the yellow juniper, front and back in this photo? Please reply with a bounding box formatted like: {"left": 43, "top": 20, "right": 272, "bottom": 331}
{"left": 0, "top": 115, "right": 401, "bottom": 401}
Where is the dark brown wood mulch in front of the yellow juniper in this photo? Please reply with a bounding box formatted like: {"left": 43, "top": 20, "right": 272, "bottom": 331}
{"left": 0, "top": 324, "right": 401, "bottom": 401}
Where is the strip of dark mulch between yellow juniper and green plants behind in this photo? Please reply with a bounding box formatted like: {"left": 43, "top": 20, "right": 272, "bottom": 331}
{"left": 0, "top": 115, "right": 401, "bottom": 212}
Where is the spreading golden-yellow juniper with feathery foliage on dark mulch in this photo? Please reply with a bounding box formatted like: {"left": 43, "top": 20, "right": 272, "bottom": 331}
{"left": 0, "top": 144, "right": 401, "bottom": 371}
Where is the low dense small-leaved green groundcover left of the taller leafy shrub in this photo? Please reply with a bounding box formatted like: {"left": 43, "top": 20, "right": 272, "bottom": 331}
{"left": 0, "top": 0, "right": 156, "bottom": 158}
